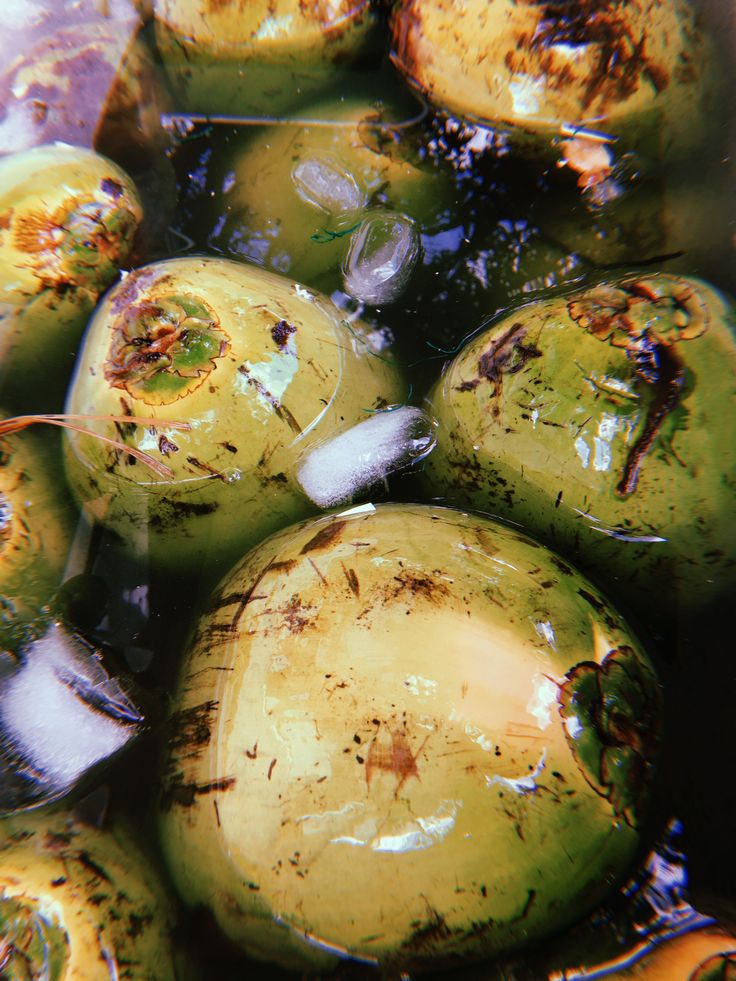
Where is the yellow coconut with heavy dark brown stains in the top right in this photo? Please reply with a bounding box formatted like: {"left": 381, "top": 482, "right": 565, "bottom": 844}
{"left": 393, "top": 0, "right": 713, "bottom": 157}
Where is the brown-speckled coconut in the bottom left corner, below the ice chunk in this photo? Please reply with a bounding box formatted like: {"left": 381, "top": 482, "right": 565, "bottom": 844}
{"left": 0, "top": 812, "right": 175, "bottom": 981}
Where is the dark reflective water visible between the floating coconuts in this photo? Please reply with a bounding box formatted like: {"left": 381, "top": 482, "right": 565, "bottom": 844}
{"left": 0, "top": 0, "right": 736, "bottom": 979}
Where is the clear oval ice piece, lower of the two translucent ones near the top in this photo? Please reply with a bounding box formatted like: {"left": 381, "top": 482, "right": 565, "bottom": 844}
{"left": 343, "top": 212, "right": 420, "bottom": 305}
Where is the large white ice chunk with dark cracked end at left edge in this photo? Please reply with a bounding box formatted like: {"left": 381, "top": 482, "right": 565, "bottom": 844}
{"left": 0, "top": 623, "right": 143, "bottom": 812}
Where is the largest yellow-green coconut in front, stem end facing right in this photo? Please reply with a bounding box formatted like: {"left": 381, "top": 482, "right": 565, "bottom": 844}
{"left": 161, "top": 505, "right": 660, "bottom": 970}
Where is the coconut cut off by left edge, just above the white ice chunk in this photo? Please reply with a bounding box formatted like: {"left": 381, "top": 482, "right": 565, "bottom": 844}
{"left": 0, "top": 420, "right": 75, "bottom": 653}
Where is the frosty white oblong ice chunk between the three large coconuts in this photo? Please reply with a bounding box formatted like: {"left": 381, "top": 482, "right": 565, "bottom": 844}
{"left": 298, "top": 405, "right": 435, "bottom": 508}
